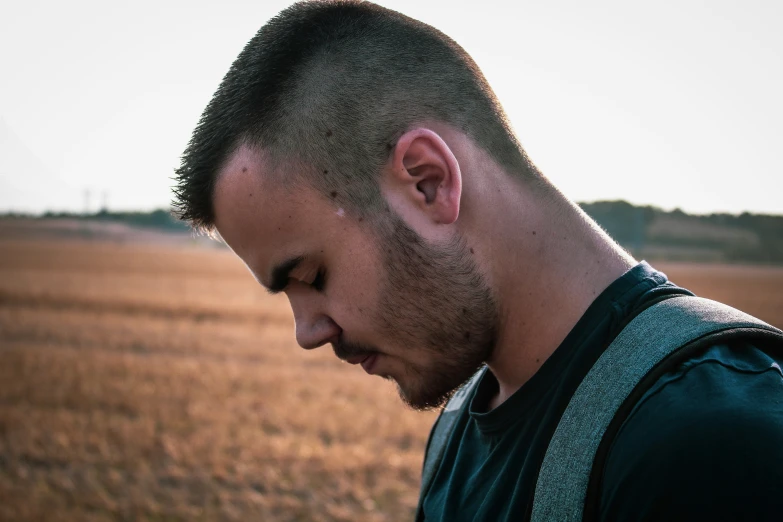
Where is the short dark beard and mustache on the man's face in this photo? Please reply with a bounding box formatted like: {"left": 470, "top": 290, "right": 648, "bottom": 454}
{"left": 356, "top": 212, "right": 499, "bottom": 410}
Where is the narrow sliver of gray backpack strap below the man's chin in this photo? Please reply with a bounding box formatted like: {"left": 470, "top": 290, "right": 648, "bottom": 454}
{"left": 416, "top": 366, "right": 487, "bottom": 520}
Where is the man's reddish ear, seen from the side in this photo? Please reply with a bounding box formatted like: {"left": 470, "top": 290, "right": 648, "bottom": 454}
{"left": 387, "top": 128, "right": 462, "bottom": 224}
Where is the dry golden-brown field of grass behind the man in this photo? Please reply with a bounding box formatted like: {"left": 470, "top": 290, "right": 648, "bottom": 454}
{"left": 0, "top": 232, "right": 783, "bottom": 521}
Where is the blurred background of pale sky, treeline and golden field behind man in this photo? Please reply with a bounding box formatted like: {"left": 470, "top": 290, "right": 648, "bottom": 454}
{"left": 0, "top": 0, "right": 783, "bottom": 521}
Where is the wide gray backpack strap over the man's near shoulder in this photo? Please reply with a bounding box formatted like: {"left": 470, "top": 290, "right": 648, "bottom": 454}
{"left": 530, "top": 296, "right": 783, "bottom": 522}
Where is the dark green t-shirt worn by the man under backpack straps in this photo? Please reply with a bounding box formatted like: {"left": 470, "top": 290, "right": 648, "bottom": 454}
{"left": 423, "top": 263, "right": 783, "bottom": 522}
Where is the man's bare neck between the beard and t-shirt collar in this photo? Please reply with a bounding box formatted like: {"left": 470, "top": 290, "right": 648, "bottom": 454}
{"left": 472, "top": 181, "right": 636, "bottom": 408}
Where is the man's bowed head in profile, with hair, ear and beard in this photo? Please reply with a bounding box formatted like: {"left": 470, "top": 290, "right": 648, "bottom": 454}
{"left": 175, "top": 1, "right": 545, "bottom": 408}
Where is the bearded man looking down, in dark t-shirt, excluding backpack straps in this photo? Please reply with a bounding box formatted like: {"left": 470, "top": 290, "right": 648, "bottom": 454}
{"left": 175, "top": 1, "right": 783, "bottom": 521}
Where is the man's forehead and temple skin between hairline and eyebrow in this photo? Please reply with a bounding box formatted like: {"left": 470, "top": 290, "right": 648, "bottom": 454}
{"left": 213, "top": 146, "right": 342, "bottom": 276}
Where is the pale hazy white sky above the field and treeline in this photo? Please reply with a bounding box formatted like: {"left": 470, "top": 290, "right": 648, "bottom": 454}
{"left": 0, "top": 0, "right": 783, "bottom": 214}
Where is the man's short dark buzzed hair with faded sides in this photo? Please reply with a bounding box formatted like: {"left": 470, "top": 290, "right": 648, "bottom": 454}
{"left": 173, "top": 0, "right": 542, "bottom": 232}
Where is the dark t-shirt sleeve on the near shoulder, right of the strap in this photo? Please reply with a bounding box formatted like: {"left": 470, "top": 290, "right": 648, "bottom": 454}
{"left": 599, "top": 346, "right": 783, "bottom": 522}
